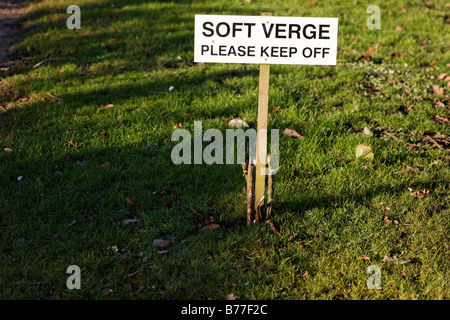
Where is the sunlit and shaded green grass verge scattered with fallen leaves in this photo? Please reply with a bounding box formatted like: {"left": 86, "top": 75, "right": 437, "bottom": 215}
{"left": 0, "top": 0, "right": 450, "bottom": 299}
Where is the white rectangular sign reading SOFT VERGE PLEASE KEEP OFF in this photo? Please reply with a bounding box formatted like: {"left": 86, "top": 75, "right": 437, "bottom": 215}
{"left": 194, "top": 15, "right": 338, "bottom": 65}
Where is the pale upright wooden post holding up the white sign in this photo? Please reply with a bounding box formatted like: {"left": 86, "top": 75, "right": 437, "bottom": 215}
{"left": 255, "top": 13, "right": 272, "bottom": 221}
